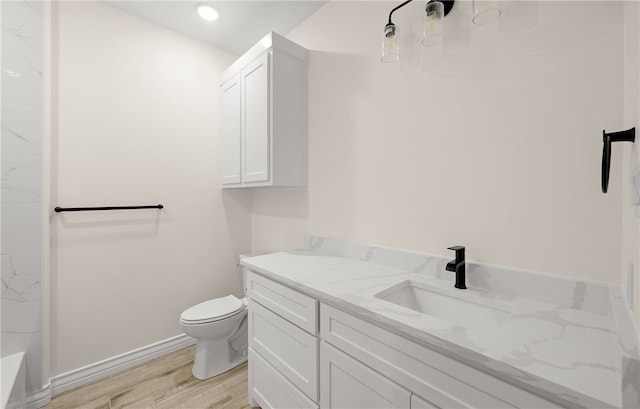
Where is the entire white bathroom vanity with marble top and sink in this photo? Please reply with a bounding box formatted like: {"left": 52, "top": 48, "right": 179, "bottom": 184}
{"left": 242, "top": 238, "right": 640, "bottom": 409}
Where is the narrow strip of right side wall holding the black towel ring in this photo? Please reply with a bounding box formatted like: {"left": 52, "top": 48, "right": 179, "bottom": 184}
{"left": 616, "top": 1, "right": 640, "bottom": 328}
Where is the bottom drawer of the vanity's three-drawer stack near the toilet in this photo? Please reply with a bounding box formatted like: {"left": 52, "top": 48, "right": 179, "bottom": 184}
{"left": 249, "top": 348, "right": 318, "bottom": 409}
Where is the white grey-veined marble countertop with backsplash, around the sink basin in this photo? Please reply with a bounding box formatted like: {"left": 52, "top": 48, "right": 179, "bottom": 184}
{"left": 242, "top": 237, "right": 640, "bottom": 408}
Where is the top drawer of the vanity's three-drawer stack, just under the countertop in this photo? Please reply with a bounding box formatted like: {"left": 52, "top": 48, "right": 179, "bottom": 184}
{"left": 247, "top": 271, "right": 318, "bottom": 335}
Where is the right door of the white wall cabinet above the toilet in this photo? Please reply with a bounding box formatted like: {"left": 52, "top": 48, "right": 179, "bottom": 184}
{"left": 242, "top": 53, "right": 271, "bottom": 183}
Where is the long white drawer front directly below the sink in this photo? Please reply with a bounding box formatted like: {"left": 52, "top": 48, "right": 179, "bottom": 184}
{"left": 320, "top": 304, "right": 558, "bottom": 409}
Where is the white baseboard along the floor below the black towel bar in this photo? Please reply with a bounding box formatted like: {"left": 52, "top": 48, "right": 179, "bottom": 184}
{"left": 27, "top": 334, "right": 196, "bottom": 408}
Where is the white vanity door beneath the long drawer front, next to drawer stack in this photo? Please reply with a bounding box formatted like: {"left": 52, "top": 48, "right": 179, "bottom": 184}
{"left": 320, "top": 342, "right": 411, "bottom": 409}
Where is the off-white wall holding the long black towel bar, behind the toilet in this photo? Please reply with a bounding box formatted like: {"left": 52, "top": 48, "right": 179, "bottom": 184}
{"left": 50, "top": 2, "right": 251, "bottom": 376}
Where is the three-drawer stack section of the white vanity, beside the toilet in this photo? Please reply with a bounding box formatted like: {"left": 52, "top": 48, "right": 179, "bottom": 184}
{"left": 247, "top": 271, "right": 319, "bottom": 409}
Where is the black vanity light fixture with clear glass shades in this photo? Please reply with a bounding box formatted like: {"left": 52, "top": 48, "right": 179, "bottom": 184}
{"left": 382, "top": 0, "right": 501, "bottom": 63}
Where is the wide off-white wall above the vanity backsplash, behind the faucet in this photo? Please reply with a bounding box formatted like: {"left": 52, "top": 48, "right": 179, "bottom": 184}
{"left": 252, "top": 1, "right": 623, "bottom": 283}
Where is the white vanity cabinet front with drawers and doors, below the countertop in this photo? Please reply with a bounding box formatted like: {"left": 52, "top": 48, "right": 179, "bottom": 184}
{"left": 247, "top": 271, "right": 559, "bottom": 409}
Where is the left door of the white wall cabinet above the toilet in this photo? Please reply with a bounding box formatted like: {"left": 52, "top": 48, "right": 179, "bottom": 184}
{"left": 220, "top": 75, "right": 242, "bottom": 185}
